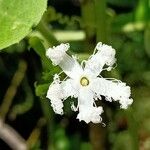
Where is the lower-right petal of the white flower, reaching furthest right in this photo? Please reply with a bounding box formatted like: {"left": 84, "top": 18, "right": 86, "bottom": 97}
{"left": 91, "top": 78, "right": 133, "bottom": 109}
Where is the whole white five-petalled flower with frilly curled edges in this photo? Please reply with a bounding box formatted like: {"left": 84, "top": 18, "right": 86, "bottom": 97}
{"left": 46, "top": 43, "right": 133, "bottom": 123}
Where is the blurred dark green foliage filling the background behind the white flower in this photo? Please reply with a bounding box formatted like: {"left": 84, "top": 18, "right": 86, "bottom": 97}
{"left": 0, "top": 0, "right": 150, "bottom": 150}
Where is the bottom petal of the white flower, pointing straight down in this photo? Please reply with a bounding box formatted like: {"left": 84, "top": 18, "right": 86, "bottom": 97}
{"left": 77, "top": 88, "right": 103, "bottom": 123}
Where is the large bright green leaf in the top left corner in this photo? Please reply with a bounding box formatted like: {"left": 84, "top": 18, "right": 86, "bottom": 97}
{"left": 0, "top": 0, "right": 47, "bottom": 49}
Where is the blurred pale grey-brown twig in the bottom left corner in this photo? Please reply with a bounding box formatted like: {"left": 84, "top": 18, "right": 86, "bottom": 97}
{"left": 0, "top": 119, "right": 27, "bottom": 150}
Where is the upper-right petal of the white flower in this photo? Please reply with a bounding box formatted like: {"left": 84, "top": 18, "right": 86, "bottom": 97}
{"left": 85, "top": 42, "right": 116, "bottom": 76}
